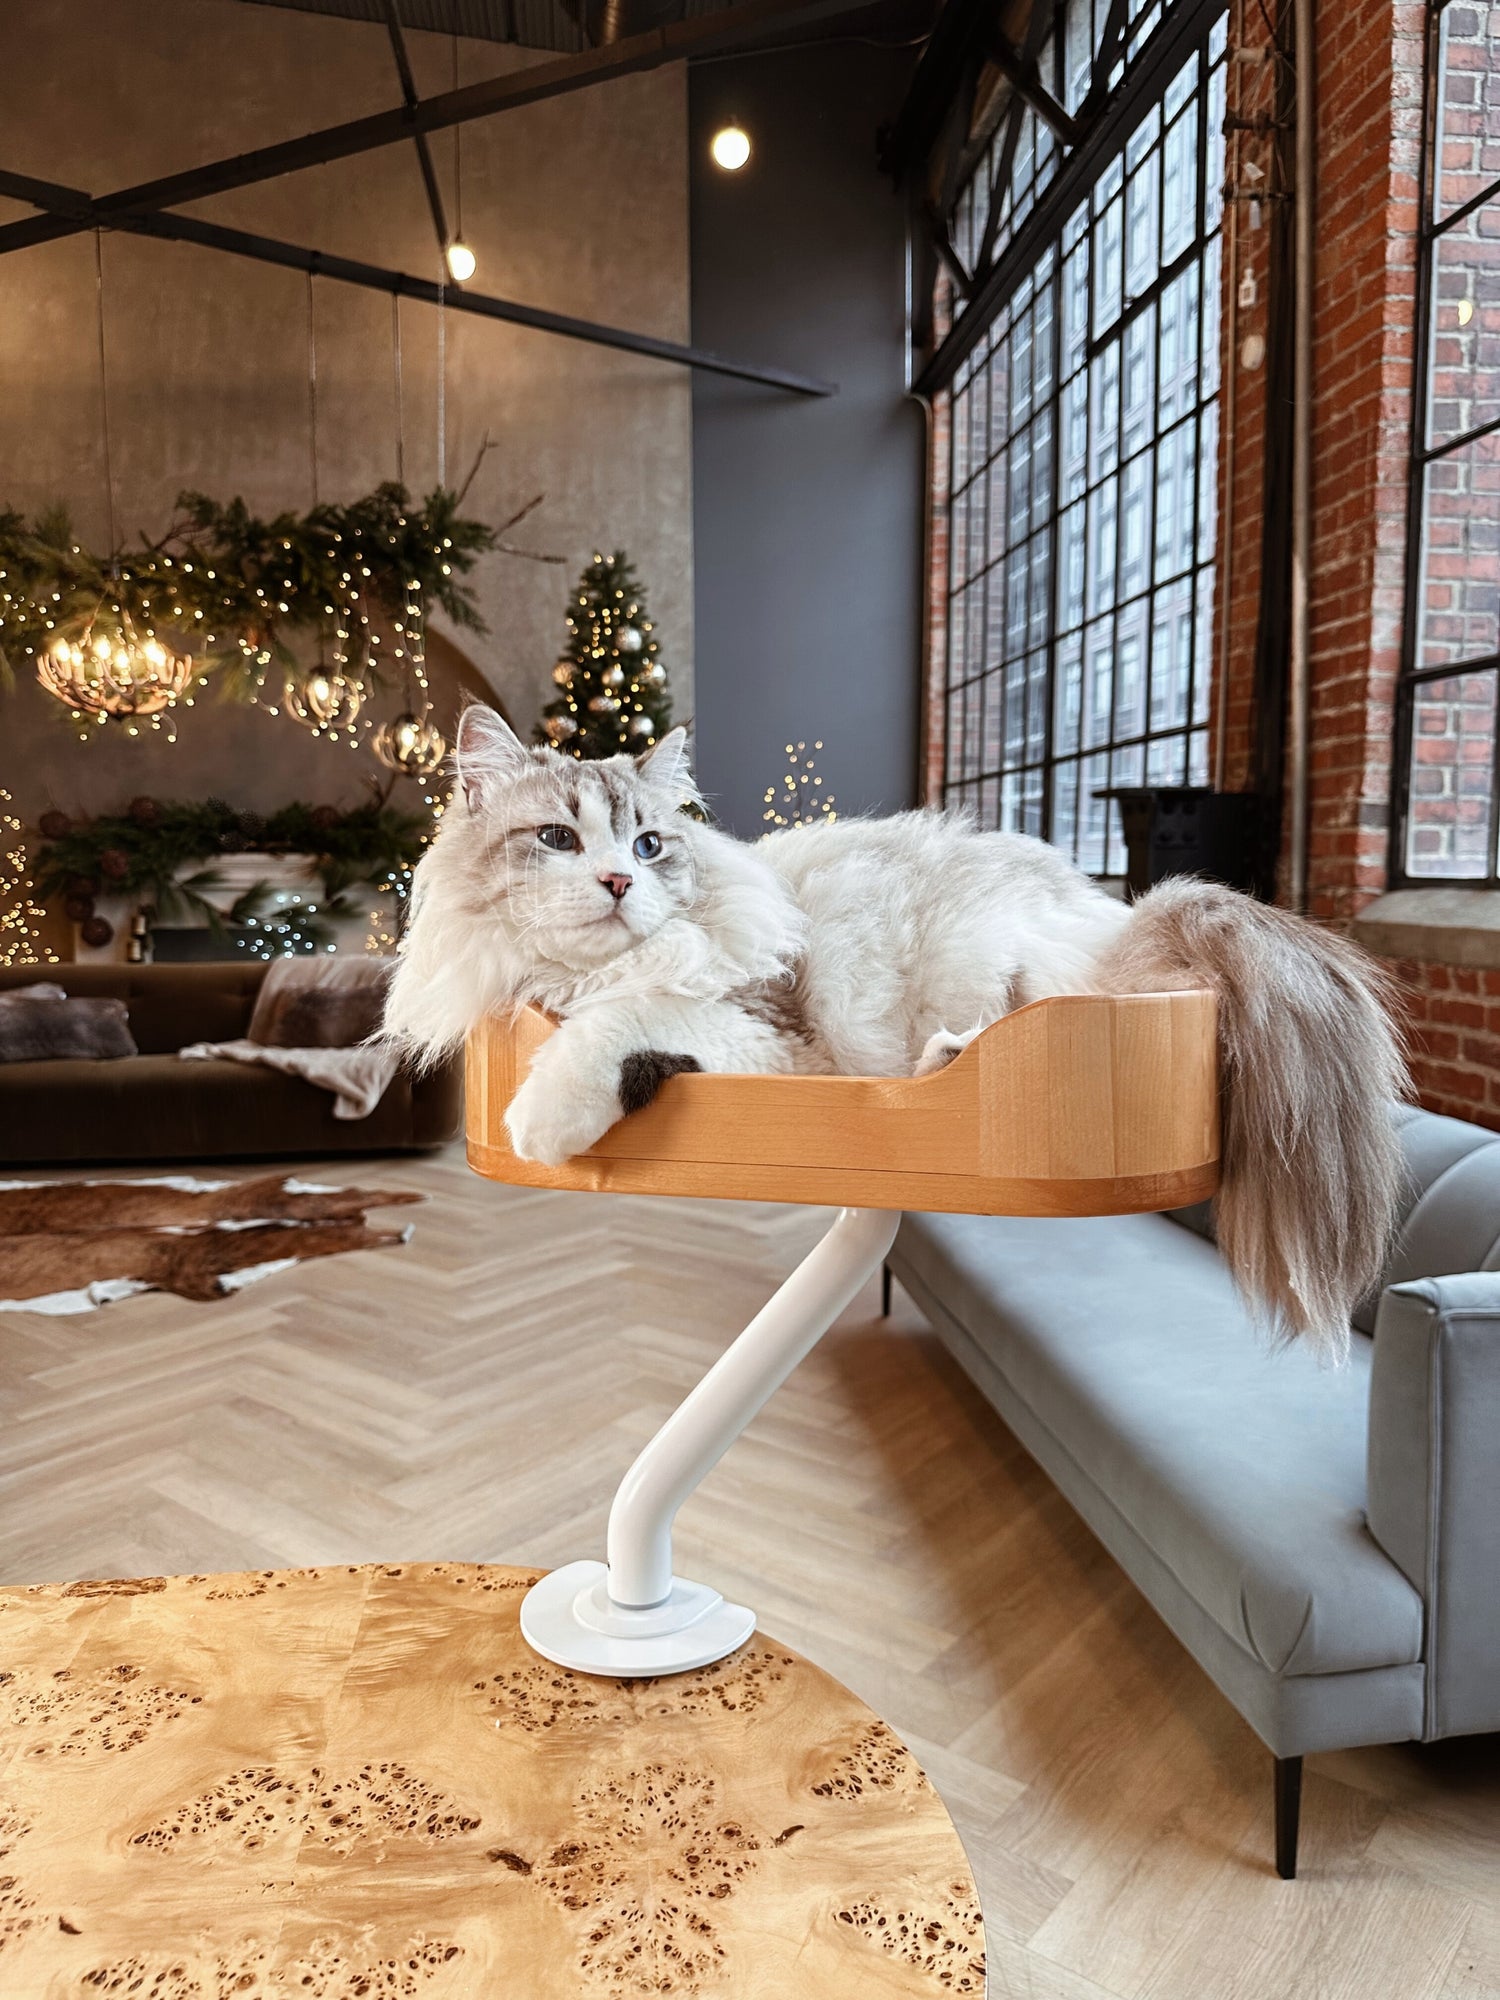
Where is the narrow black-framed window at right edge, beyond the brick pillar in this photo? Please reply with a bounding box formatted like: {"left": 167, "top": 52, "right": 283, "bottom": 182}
{"left": 1392, "top": 4, "right": 1500, "bottom": 886}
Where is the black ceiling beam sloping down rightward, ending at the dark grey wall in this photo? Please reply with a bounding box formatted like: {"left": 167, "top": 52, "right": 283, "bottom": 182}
{"left": 0, "top": 170, "right": 838, "bottom": 396}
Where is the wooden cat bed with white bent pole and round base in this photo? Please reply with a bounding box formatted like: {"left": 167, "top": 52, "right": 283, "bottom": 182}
{"left": 468, "top": 992, "right": 1218, "bottom": 1676}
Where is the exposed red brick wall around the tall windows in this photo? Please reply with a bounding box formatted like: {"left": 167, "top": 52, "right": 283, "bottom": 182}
{"left": 1218, "top": 0, "right": 1500, "bottom": 1128}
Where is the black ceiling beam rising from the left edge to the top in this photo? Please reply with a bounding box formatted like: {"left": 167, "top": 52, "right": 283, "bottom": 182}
{"left": 0, "top": 0, "right": 866, "bottom": 254}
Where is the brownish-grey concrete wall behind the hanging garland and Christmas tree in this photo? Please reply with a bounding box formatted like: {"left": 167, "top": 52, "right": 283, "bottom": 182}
{"left": 0, "top": 0, "right": 692, "bottom": 820}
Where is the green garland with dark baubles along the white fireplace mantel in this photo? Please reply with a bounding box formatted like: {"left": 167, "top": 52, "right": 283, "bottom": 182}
{"left": 36, "top": 798, "right": 440, "bottom": 956}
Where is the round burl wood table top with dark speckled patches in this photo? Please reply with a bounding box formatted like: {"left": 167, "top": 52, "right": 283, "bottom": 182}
{"left": 0, "top": 1562, "right": 984, "bottom": 2000}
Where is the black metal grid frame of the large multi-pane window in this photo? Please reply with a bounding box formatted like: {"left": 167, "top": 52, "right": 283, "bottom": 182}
{"left": 916, "top": 0, "right": 1228, "bottom": 872}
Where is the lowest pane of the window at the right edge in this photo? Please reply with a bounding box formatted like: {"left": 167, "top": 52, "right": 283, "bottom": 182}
{"left": 1406, "top": 672, "right": 1496, "bottom": 880}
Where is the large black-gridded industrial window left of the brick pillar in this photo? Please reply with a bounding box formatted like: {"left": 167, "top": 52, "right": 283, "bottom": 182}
{"left": 934, "top": 0, "right": 1226, "bottom": 874}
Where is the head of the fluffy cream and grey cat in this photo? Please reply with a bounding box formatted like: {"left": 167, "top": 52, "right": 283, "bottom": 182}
{"left": 450, "top": 704, "right": 696, "bottom": 970}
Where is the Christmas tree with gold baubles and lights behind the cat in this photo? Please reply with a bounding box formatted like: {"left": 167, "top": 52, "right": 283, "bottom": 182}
{"left": 536, "top": 550, "right": 672, "bottom": 758}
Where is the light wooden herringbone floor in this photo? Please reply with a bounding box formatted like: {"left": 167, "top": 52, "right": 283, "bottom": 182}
{"left": 0, "top": 1150, "right": 1500, "bottom": 2000}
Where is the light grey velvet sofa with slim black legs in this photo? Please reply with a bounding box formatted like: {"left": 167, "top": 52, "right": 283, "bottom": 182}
{"left": 888, "top": 1108, "right": 1500, "bottom": 1876}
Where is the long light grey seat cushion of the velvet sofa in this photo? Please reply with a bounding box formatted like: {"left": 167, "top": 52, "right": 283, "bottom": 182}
{"left": 896, "top": 1216, "right": 1422, "bottom": 1674}
